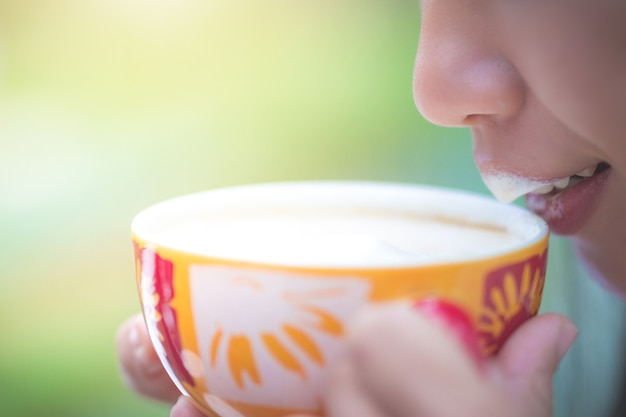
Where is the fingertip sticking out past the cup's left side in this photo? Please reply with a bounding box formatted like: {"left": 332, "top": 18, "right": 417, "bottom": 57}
{"left": 116, "top": 315, "right": 180, "bottom": 403}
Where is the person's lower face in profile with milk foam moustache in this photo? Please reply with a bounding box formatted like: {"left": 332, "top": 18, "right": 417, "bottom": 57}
{"left": 414, "top": 0, "right": 626, "bottom": 295}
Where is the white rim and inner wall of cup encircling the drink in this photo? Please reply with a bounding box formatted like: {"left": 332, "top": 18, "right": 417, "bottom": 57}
{"left": 131, "top": 181, "right": 549, "bottom": 270}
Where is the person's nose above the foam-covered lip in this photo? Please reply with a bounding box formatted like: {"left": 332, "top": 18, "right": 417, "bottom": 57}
{"left": 413, "top": 0, "right": 526, "bottom": 126}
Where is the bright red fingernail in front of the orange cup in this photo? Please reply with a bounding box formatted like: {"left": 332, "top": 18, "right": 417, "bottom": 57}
{"left": 413, "top": 298, "right": 484, "bottom": 366}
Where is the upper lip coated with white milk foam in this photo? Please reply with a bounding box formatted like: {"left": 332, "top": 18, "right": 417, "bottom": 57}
{"left": 481, "top": 162, "right": 609, "bottom": 202}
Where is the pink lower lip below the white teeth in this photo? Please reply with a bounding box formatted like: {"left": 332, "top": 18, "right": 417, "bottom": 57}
{"left": 526, "top": 168, "right": 611, "bottom": 235}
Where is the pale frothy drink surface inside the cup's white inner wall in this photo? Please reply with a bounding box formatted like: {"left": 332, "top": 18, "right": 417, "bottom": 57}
{"left": 159, "top": 209, "right": 524, "bottom": 267}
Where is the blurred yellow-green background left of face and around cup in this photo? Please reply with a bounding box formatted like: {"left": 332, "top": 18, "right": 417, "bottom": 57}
{"left": 0, "top": 0, "right": 620, "bottom": 417}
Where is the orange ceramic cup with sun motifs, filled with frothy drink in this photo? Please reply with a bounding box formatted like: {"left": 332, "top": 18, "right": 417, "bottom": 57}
{"left": 132, "top": 182, "right": 548, "bottom": 417}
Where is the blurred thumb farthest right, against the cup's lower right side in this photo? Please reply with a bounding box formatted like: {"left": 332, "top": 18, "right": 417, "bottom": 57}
{"left": 496, "top": 314, "right": 578, "bottom": 408}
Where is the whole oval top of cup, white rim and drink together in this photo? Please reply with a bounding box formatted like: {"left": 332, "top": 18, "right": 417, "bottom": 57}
{"left": 132, "top": 182, "right": 548, "bottom": 268}
